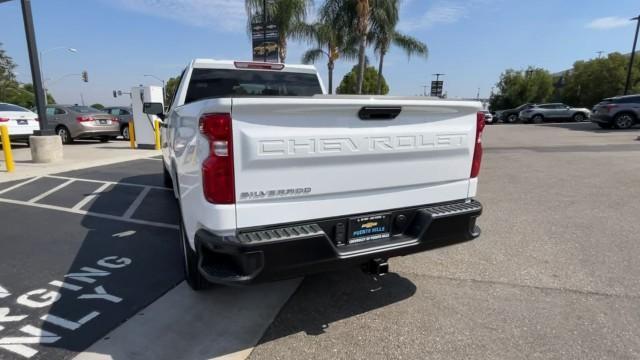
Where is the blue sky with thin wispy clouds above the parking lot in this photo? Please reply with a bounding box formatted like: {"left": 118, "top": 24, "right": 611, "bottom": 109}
{"left": 0, "top": 0, "right": 640, "bottom": 105}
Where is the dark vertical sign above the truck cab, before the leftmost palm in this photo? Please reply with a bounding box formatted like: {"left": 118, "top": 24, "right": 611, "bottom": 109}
{"left": 251, "top": 0, "right": 279, "bottom": 62}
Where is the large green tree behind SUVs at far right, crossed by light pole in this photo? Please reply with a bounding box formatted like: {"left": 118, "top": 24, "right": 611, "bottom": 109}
{"left": 560, "top": 53, "right": 640, "bottom": 107}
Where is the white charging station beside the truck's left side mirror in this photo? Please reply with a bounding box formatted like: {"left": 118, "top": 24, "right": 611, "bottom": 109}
{"left": 131, "top": 86, "right": 164, "bottom": 149}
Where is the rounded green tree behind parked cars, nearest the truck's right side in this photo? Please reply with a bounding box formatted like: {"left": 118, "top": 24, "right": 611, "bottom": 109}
{"left": 489, "top": 66, "right": 554, "bottom": 110}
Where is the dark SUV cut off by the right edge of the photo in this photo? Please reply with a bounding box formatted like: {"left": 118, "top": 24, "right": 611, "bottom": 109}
{"left": 591, "top": 94, "right": 640, "bottom": 129}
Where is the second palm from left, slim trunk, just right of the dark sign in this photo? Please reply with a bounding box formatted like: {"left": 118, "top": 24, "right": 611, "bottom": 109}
{"left": 297, "top": 0, "right": 358, "bottom": 94}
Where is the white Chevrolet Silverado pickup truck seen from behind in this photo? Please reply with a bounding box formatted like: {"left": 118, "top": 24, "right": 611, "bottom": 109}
{"left": 144, "top": 59, "right": 484, "bottom": 290}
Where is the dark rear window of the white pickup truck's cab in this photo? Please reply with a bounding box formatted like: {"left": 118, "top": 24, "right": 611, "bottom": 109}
{"left": 185, "top": 69, "right": 322, "bottom": 104}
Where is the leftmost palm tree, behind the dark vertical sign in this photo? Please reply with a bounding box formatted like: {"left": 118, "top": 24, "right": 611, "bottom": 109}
{"left": 244, "top": 0, "right": 313, "bottom": 63}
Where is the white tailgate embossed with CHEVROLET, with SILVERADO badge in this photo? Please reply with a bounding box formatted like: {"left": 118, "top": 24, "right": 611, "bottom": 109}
{"left": 232, "top": 96, "right": 481, "bottom": 228}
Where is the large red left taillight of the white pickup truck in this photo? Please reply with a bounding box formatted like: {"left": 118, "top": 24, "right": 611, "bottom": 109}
{"left": 199, "top": 114, "right": 236, "bottom": 204}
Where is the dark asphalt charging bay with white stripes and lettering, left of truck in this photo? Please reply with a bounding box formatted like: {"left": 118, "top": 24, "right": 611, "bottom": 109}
{"left": 0, "top": 159, "right": 183, "bottom": 359}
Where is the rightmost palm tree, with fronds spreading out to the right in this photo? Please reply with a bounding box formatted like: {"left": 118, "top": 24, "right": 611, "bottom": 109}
{"left": 368, "top": 0, "right": 429, "bottom": 94}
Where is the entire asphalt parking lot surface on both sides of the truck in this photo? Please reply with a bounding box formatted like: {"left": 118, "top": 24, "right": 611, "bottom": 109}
{"left": 0, "top": 123, "right": 640, "bottom": 359}
